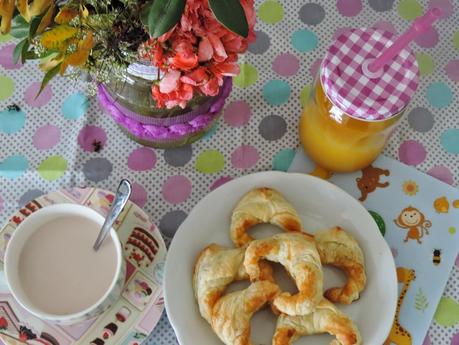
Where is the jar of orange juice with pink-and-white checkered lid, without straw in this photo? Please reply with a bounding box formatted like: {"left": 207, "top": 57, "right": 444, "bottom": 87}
{"left": 299, "top": 29, "right": 419, "bottom": 172}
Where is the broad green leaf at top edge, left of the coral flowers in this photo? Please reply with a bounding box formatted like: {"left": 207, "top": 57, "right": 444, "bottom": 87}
{"left": 147, "top": 0, "right": 185, "bottom": 38}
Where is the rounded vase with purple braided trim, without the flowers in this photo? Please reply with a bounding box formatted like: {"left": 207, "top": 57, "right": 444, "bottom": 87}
{"left": 98, "top": 64, "right": 232, "bottom": 148}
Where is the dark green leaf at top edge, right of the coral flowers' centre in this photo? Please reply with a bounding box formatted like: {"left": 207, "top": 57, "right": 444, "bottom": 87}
{"left": 209, "top": 0, "right": 249, "bottom": 37}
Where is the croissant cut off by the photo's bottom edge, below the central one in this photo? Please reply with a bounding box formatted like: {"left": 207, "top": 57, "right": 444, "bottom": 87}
{"left": 272, "top": 298, "right": 362, "bottom": 345}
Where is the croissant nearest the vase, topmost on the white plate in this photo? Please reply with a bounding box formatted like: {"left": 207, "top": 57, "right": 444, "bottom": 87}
{"left": 230, "top": 188, "right": 302, "bottom": 247}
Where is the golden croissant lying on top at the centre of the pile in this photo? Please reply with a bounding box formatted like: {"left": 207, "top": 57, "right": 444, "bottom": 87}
{"left": 244, "top": 233, "right": 323, "bottom": 315}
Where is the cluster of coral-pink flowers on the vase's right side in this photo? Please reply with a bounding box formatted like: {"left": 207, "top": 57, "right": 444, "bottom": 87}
{"left": 146, "top": 0, "right": 256, "bottom": 109}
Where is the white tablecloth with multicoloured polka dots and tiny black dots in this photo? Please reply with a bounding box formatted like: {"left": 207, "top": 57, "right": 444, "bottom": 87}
{"left": 0, "top": 0, "right": 459, "bottom": 345}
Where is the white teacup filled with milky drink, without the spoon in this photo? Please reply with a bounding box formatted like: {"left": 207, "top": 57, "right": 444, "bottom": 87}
{"left": 5, "top": 204, "right": 125, "bottom": 324}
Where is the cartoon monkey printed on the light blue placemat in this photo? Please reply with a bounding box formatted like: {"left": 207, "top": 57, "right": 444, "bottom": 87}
{"left": 394, "top": 206, "right": 432, "bottom": 244}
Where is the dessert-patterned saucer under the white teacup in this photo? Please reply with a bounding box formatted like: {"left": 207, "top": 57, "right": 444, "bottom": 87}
{"left": 0, "top": 188, "right": 166, "bottom": 345}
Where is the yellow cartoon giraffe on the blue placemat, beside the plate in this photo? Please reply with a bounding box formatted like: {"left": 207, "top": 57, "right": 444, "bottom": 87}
{"left": 384, "top": 267, "right": 416, "bottom": 345}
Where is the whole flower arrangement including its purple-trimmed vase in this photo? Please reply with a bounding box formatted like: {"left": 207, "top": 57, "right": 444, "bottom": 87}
{"left": 0, "top": 0, "right": 255, "bottom": 147}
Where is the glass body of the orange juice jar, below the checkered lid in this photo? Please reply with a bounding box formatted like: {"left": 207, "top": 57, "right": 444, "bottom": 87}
{"left": 299, "top": 78, "right": 404, "bottom": 172}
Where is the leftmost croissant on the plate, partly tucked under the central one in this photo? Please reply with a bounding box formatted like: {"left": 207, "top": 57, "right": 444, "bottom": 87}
{"left": 193, "top": 244, "right": 273, "bottom": 323}
